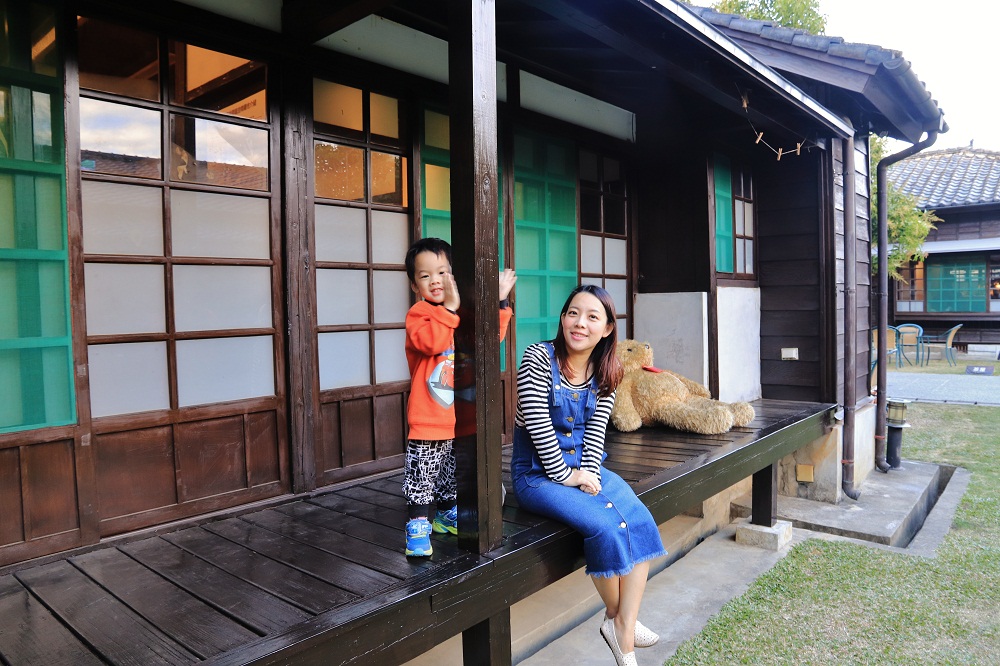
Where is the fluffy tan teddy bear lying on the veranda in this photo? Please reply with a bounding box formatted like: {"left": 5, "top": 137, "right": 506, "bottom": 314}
{"left": 611, "top": 340, "right": 754, "bottom": 435}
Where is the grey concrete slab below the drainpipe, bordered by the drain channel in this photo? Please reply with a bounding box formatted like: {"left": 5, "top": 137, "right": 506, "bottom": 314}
{"left": 732, "top": 460, "right": 948, "bottom": 548}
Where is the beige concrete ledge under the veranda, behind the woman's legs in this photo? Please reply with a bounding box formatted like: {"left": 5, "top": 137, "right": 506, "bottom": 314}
{"left": 406, "top": 516, "right": 709, "bottom": 666}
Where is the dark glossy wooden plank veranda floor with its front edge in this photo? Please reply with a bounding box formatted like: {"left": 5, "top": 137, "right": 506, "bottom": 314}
{"left": 0, "top": 400, "right": 832, "bottom": 666}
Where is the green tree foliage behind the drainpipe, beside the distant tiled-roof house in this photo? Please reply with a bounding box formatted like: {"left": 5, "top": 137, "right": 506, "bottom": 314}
{"left": 868, "top": 136, "right": 941, "bottom": 280}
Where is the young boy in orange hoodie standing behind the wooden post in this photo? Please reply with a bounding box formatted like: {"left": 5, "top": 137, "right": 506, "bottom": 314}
{"left": 403, "top": 238, "right": 517, "bottom": 557}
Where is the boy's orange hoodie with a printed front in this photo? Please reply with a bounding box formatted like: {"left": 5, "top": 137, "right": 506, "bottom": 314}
{"left": 406, "top": 301, "right": 513, "bottom": 440}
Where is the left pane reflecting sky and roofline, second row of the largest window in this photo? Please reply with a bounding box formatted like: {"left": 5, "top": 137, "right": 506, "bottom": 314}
{"left": 80, "top": 97, "right": 162, "bottom": 178}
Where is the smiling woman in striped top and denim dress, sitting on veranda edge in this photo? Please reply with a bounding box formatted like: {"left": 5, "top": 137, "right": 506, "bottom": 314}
{"left": 511, "top": 285, "right": 666, "bottom": 666}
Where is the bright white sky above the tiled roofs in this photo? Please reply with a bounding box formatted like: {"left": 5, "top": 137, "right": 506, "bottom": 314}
{"left": 693, "top": 0, "right": 1000, "bottom": 151}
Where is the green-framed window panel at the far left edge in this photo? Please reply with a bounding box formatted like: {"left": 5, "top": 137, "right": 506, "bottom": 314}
{"left": 0, "top": 3, "right": 76, "bottom": 433}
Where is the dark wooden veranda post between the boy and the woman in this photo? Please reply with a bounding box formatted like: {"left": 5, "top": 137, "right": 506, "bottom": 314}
{"left": 448, "top": 0, "right": 503, "bottom": 553}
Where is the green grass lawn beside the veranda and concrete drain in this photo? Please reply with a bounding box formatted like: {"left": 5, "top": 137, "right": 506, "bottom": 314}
{"left": 666, "top": 403, "right": 1000, "bottom": 666}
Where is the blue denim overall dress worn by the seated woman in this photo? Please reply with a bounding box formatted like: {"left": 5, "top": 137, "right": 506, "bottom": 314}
{"left": 511, "top": 344, "right": 667, "bottom": 578}
